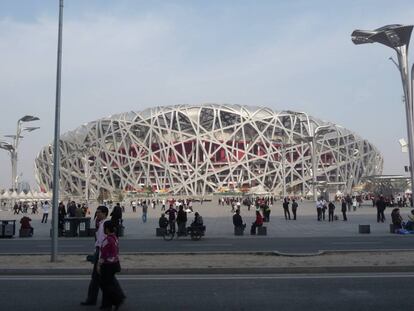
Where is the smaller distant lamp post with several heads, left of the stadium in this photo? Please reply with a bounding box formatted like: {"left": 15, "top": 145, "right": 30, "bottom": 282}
{"left": 0, "top": 115, "right": 40, "bottom": 191}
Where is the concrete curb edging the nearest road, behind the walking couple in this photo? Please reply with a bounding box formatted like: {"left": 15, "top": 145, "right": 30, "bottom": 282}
{"left": 0, "top": 266, "right": 414, "bottom": 276}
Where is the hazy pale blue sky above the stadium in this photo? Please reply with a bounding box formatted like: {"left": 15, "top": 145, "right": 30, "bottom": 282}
{"left": 0, "top": 0, "right": 414, "bottom": 188}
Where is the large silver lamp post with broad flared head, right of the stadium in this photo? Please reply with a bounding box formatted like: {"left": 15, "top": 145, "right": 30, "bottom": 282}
{"left": 351, "top": 24, "right": 414, "bottom": 197}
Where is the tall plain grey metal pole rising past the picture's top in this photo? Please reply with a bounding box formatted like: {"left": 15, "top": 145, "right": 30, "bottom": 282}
{"left": 51, "top": 0, "right": 63, "bottom": 262}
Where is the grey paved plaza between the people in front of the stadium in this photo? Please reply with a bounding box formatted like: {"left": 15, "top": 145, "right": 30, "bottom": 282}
{"left": 0, "top": 198, "right": 411, "bottom": 239}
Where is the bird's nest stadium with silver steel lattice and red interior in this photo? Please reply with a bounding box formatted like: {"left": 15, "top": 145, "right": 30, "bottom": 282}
{"left": 35, "top": 104, "right": 383, "bottom": 198}
